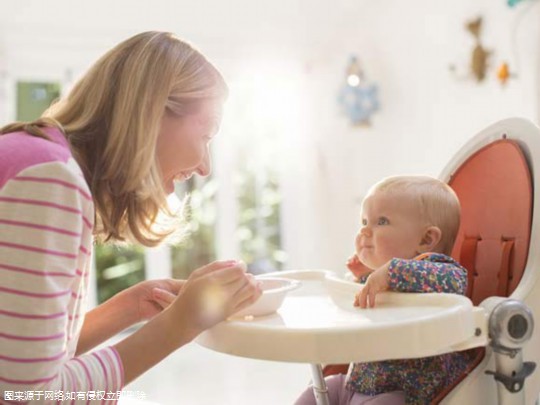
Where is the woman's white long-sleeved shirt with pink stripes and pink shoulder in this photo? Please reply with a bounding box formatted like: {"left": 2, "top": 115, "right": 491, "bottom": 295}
{"left": 0, "top": 129, "right": 123, "bottom": 403}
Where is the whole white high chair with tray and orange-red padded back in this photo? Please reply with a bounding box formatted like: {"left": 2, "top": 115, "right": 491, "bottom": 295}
{"left": 197, "top": 118, "right": 540, "bottom": 405}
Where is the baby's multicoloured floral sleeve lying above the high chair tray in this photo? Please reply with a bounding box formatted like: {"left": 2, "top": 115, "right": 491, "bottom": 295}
{"left": 388, "top": 259, "right": 467, "bottom": 294}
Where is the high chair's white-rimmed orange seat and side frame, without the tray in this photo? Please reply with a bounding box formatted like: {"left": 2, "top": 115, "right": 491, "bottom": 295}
{"left": 430, "top": 118, "right": 540, "bottom": 404}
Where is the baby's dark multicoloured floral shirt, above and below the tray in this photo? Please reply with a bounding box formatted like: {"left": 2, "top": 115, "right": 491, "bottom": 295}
{"left": 347, "top": 253, "right": 470, "bottom": 405}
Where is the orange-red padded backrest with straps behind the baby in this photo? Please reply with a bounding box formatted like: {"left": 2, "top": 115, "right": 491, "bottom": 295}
{"left": 448, "top": 139, "right": 533, "bottom": 305}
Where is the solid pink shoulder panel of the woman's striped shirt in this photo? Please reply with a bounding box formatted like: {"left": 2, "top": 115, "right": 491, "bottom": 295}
{"left": 0, "top": 128, "right": 72, "bottom": 187}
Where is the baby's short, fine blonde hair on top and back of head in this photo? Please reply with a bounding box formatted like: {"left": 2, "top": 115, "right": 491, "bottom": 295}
{"left": 368, "top": 176, "right": 461, "bottom": 255}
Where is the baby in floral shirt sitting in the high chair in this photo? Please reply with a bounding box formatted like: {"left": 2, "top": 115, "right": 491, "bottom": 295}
{"left": 295, "top": 176, "right": 469, "bottom": 405}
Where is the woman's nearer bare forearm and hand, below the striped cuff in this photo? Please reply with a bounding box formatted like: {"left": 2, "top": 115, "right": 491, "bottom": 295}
{"left": 114, "top": 262, "right": 261, "bottom": 384}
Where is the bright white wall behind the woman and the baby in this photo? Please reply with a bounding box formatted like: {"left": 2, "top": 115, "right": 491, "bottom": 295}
{"left": 0, "top": 0, "right": 540, "bottom": 269}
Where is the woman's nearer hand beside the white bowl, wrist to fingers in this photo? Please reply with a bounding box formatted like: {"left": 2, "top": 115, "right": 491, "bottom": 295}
{"left": 167, "top": 261, "right": 262, "bottom": 336}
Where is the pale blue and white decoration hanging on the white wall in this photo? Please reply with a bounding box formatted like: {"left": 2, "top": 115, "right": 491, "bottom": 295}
{"left": 338, "top": 55, "right": 379, "bottom": 126}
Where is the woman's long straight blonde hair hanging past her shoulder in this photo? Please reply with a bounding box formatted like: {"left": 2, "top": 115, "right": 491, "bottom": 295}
{"left": 0, "top": 32, "right": 227, "bottom": 246}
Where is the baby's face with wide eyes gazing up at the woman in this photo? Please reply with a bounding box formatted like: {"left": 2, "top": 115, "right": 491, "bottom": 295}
{"left": 356, "top": 192, "right": 426, "bottom": 269}
